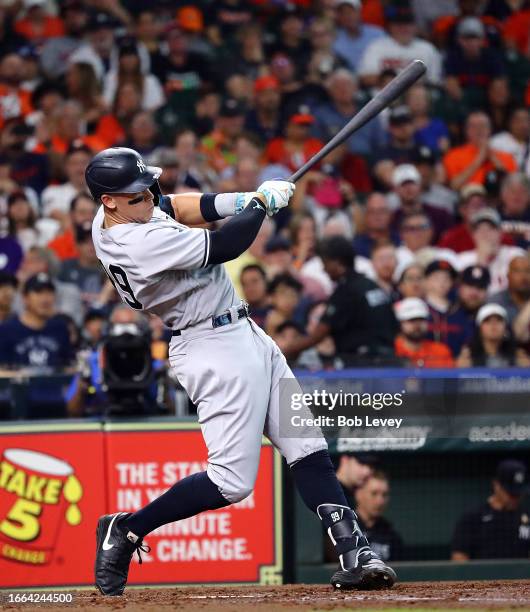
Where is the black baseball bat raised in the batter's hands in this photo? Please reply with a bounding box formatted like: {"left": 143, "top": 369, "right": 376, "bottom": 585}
{"left": 287, "top": 60, "right": 426, "bottom": 183}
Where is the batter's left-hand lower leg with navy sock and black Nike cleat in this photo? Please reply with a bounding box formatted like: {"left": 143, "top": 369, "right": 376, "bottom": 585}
{"left": 95, "top": 472, "right": 230, "bottom": 595}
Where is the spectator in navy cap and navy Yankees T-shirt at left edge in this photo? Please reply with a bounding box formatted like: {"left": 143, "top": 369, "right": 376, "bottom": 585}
{"left": 0, "top": 273, "right": 73, "bottom": 367}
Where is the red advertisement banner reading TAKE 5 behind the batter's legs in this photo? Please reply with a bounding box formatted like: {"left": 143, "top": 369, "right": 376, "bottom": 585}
{"left": 0, "top": 423, "right": 282, "bottom": 588}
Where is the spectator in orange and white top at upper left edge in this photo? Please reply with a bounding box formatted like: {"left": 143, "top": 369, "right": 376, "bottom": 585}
{"left": 0, "top": 53, "right": 33, "bottom": 129}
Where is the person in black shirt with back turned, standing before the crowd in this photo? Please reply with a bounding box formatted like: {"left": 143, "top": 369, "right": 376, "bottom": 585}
{"left": 278, "top": 236, "right": 398, "bottom": 365}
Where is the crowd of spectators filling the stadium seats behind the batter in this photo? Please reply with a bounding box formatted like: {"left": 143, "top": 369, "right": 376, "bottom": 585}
{"left": 0, "top": 0, "right": 530, "bottom": 404}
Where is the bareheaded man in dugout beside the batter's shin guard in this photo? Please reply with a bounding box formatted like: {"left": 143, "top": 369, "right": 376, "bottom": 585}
{"left": 355, "top": 470, "right": 403, "bottom": 561}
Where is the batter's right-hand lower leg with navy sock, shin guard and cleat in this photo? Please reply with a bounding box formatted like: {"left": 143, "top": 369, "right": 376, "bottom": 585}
{"left": 291, "top": 450, "right": 396, "bottom": 590}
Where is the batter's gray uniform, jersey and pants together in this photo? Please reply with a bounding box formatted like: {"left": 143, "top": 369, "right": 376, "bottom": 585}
{"left": 92, "top": 207, "right": 327, "bottom": 502}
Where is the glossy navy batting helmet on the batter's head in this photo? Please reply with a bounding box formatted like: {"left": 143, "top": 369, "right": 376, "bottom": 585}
{"left": 85, "top": 147, "right": 162, "bottom": 201}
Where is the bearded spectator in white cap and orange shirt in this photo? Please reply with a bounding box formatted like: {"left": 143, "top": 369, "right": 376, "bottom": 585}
{"left": 394, "top": 297, "right": 454, "bottom": 368}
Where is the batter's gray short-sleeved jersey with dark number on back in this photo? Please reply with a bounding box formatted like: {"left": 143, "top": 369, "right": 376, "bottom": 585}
{"left": 92, "top": 206, "right": 236, "bottom": 329}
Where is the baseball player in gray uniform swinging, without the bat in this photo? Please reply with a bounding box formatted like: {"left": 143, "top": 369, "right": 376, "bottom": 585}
{"left": 86, "top": 148, "right": 396, "bottom": 595}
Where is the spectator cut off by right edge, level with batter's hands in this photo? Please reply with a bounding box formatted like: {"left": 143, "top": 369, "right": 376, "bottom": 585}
{"left": 499, "top": 172, "right": 530, "bottom": 249}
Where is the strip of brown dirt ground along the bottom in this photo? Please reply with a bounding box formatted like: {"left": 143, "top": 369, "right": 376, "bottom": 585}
{"left": 1, "top": 580, "right": 530, "bottom": 612}
